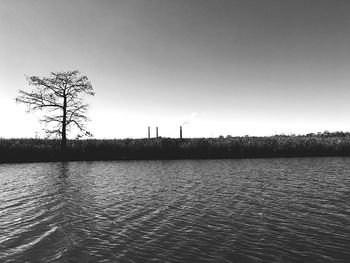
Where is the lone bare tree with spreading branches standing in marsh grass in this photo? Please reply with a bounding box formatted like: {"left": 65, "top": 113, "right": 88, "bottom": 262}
{"left": 16, "top": 70, "right": 95, "bottom": 150}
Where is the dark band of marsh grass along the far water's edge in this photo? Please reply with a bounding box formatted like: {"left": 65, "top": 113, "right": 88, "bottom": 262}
{"left": 0, "top": 132, "right": 350, "bottom": 163}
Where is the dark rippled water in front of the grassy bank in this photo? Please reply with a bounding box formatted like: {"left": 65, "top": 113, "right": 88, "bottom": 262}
{"left": 0, "top": 158, "right": 350, "bottom": 262}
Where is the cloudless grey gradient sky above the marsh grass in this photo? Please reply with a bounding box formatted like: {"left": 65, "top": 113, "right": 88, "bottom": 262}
{"left": 0, "top": 0, "right": 350, "bottom": 138}
